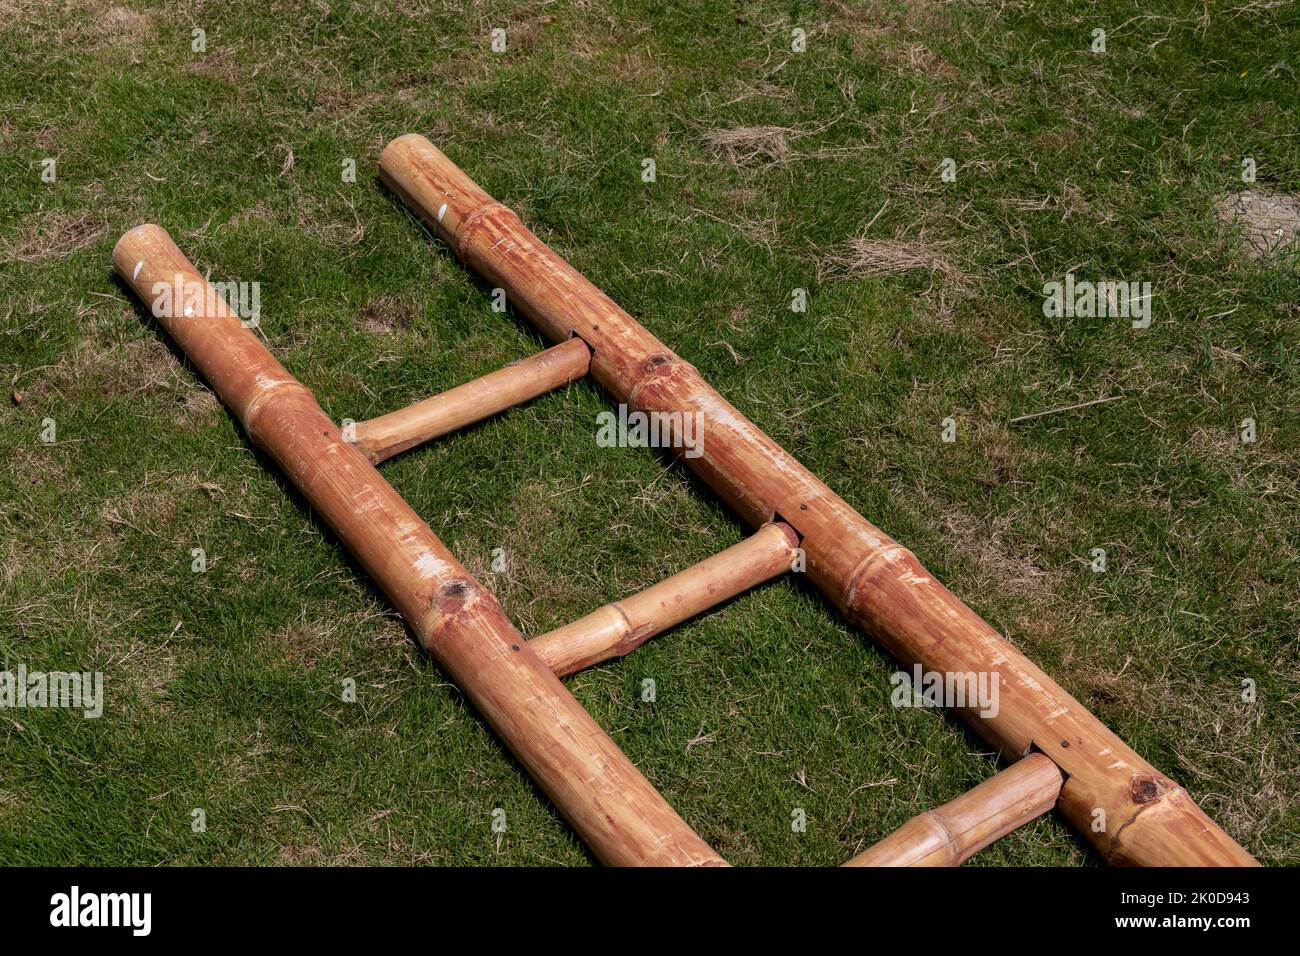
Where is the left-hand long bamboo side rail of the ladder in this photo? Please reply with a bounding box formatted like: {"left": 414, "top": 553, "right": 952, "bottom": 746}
{"left": 113, "top": 225, "right": 723, "bottom": 865}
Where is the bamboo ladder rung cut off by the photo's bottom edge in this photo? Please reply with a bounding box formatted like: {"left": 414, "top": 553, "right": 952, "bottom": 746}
{"left": 844, "top": 753, "right": 1063, "bottom": 866}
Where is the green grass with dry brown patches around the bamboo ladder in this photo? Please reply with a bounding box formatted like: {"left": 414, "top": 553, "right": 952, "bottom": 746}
{"left": 0, "top": 0, "right": 1300, "bottom": 865}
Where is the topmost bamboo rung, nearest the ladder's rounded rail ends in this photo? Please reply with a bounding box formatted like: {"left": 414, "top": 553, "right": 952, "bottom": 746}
{"left": 356, "top": 338, "right": 592, "bottom": 463}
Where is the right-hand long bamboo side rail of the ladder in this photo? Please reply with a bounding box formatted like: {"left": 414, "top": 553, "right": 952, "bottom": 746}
{"left": 380, "top": 134, "right": 1255, "bottom": 865}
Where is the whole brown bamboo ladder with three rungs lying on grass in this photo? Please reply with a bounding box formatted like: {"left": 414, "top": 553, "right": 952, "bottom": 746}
{"left": 113, "top": 135, "right": 1256, "bottom": 866}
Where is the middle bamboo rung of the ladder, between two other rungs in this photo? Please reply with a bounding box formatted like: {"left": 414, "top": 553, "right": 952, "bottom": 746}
{"left": 528, "top": 522, "right": 800, "bottom": 678}
